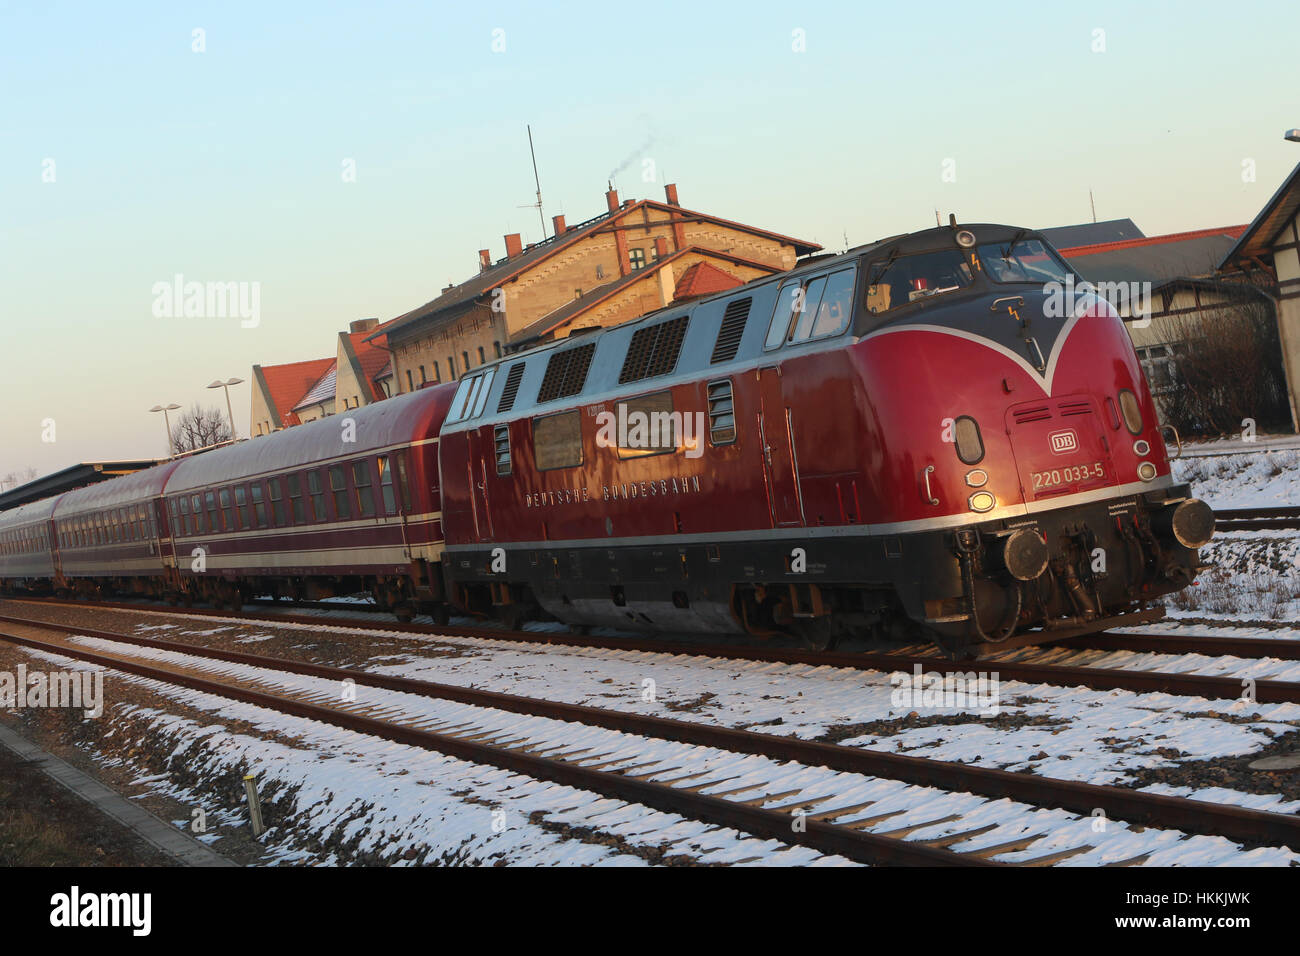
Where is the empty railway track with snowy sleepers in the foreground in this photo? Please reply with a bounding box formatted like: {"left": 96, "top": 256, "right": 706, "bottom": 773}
{"left": 0, "top": 617, "right": 1300, "bottom": 865}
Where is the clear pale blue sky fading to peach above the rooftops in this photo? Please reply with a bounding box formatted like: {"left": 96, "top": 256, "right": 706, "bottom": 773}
{"left": 0, "top": 0, "right": 1300, "bottom": 475}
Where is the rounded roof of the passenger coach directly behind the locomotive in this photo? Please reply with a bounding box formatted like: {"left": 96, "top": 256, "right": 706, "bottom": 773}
{"left": 166, "top": 384, "right": 452, "bottom": 494}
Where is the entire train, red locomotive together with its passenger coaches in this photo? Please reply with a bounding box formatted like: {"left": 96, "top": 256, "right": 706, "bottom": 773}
{"left": 0, "top": 221, "right": 1214, "bottom": 656}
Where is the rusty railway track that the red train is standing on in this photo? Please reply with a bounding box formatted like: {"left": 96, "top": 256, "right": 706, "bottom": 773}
{"left": 7, "top": 598, "right": 1300, "bottom": 704}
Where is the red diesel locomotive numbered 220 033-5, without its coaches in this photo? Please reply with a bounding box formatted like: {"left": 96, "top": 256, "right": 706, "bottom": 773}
{"left": 441, "top": 224, "right": 1214, "bottom": 653}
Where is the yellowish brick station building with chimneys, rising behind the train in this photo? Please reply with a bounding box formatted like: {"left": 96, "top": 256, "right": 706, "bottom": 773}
{"left": 250, "top": 183, "right": 822, "bottom": 437}
